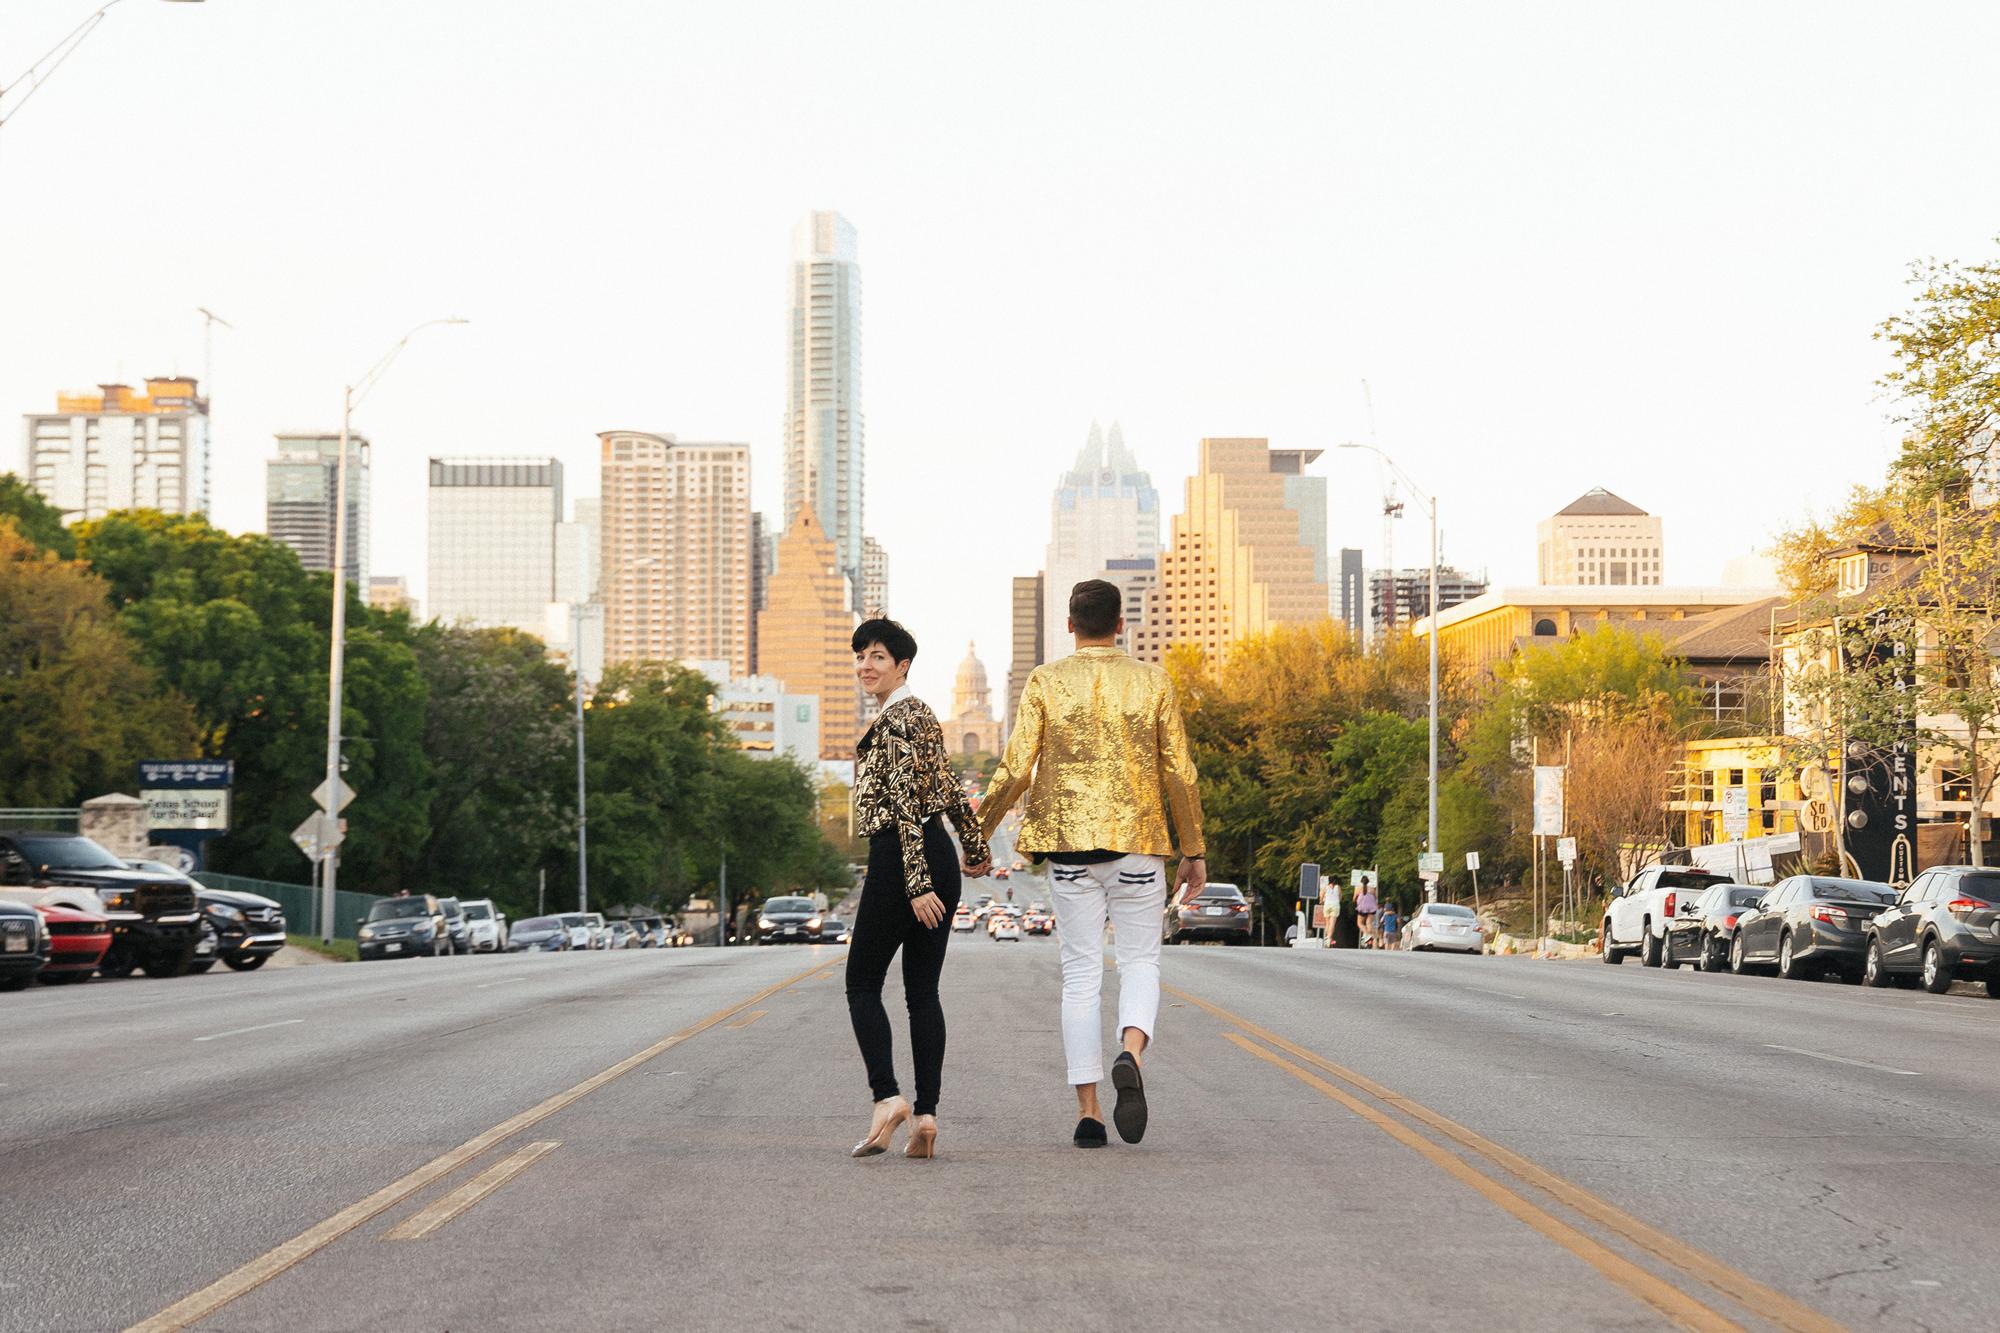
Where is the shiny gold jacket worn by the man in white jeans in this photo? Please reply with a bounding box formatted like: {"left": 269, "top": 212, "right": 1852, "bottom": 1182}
{"left": 980, "top": 648, "right": 1204, "bottom": 857}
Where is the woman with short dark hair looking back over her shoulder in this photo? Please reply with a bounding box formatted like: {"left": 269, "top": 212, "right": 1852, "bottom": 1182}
{"left": 848, "top": 618, "right": 988, "bottom": 1157}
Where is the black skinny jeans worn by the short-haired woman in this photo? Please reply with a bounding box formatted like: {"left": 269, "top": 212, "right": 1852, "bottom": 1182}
{"left": 848, "top": 815, "right": 958, "bottom": 1115}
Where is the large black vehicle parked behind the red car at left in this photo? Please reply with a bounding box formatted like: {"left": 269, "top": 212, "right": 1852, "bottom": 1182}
{"left": 0, "top": 829, "right": 202, "bottom": 977}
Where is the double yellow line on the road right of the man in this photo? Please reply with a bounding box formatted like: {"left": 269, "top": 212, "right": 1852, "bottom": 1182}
{"left": 1162, "top": 987, "right": 1842, "bottom": 1333}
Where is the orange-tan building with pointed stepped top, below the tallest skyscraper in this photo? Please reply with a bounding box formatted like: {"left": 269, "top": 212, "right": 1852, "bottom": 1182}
{"left": 756, "top": 504, "right": 862, "bottom": 759}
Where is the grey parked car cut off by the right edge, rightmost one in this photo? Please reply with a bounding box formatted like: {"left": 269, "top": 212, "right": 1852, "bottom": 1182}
{"left": 1862, "top": 865, "right": 2000, "bottom": 999}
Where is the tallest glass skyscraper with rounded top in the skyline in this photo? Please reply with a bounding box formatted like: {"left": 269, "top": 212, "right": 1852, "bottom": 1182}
{"left": 784, "top": 212, "right": 866, "bottom": 598}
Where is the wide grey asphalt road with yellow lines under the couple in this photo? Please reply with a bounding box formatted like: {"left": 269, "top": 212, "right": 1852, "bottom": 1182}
{"left": 0, "top": 920, "right": 2000, "bottom": 1333}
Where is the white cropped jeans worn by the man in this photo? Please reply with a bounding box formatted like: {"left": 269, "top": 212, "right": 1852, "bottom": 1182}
{"left": 1048, "top": 857, "right": 1166, "bottom": 1085}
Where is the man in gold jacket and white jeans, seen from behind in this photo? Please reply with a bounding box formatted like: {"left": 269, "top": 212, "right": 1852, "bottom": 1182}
{"left": 966, "top": 578, "right": 1208, "bottom": 1147}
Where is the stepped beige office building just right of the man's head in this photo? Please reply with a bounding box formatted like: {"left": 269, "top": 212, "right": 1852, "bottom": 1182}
{"left": 1132, "top": 438, "right": 1328, "bottom": 662}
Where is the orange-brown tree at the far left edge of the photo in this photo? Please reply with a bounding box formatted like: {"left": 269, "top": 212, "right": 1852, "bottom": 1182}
{"left": 0, "top": 516, "right": 194, "bottom": 807}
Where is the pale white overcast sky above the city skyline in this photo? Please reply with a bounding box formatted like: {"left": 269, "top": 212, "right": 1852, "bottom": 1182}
{"left": 0, "top": 0, "right": 2000, "bottom": 705}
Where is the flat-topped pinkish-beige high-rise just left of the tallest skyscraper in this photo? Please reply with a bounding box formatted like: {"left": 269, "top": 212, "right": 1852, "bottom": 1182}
{"left": 598, "top": 430, "right": 750, "bottom": 677}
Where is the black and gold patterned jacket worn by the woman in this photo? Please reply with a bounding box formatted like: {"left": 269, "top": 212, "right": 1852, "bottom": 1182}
{"left": 854, "top": 697, "right": 986, "bottom": 899}
